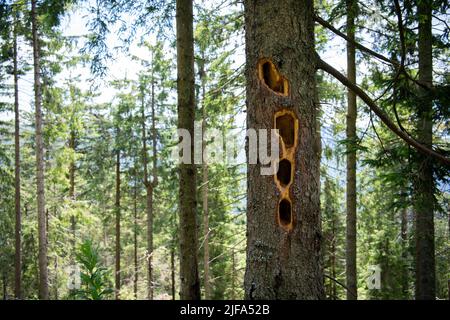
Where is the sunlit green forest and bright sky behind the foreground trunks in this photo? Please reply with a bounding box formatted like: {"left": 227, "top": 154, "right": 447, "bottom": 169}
{"left": 0, "top": 0, "right": 450, "bottom": 300}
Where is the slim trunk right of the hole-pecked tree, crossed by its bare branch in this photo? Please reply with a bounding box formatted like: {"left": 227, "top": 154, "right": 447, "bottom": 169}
{"left": 345, "top": 0, "right": 358, "bottom": 300}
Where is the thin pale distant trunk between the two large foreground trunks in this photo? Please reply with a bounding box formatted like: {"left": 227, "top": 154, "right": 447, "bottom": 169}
{"left": 199, "top": 55, "right": 211, "bottom": 300}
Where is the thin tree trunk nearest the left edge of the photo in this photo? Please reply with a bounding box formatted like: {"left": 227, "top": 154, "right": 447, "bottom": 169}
{"left": 13, "top": 11, "right": 22, "bottom": 299}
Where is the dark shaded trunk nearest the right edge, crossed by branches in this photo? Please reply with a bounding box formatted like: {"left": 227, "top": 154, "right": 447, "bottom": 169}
{"left": 414, "top": 0, "right": 436, "bottom": 300}
